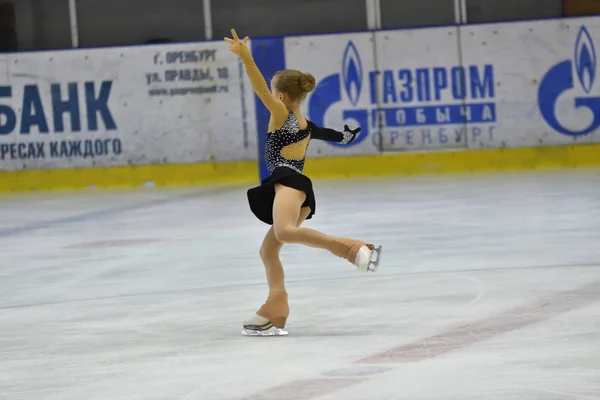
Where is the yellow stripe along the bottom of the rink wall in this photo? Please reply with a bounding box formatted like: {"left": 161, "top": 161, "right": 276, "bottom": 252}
{"left": 0, "top": 144, "right": 600, "bottom": 192}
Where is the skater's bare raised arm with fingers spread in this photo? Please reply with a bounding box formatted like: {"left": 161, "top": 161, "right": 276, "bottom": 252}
{"left": 225, "top": 29, "right": 288, "bottom": 128}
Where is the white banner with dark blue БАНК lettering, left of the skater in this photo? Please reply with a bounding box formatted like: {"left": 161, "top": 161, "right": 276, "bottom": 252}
{"left": 0, "top": 42, "right": 256, "bottom": 170}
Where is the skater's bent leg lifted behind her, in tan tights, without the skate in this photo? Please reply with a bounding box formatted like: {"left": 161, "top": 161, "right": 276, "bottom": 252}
{"left": 273, "top": 184, "right": 367, "bottom": 263}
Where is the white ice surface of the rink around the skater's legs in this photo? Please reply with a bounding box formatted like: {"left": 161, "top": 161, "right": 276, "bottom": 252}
{"left": 0, "top": 170, "right": 600, "bottom": 400}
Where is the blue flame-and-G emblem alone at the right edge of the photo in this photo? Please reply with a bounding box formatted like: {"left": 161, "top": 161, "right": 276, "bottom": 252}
{"left": 538, "top": 26, "right": 600, "bottom": 136}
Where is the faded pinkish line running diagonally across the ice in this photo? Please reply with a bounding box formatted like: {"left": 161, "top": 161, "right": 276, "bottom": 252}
{"left": 243, "top": 281, "right": 600, "bottom": 400}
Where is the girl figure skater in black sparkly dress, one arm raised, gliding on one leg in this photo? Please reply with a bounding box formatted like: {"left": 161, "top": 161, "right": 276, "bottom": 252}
{"left": 225, "top": 29, "right": 381, "bottom": 336}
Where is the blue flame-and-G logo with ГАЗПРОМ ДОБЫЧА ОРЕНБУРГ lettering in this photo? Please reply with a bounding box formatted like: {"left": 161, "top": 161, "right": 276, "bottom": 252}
{"left": 307, "top": 40, "right": 496, "bottom": 147}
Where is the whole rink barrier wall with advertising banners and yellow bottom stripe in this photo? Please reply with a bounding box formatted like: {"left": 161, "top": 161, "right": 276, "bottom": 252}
{"left": 0, "top": 17, "right": 600, "bottom": 191}
